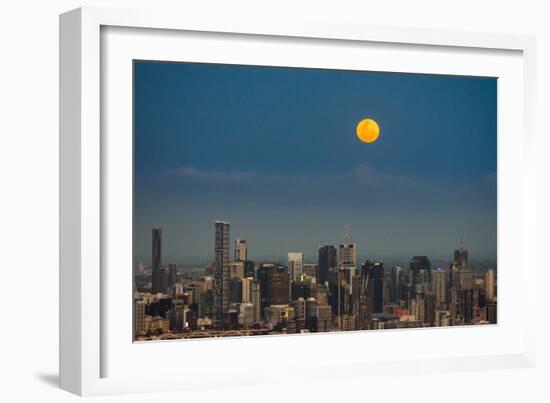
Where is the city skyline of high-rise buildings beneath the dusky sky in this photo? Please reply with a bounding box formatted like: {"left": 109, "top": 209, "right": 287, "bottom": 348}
{"left": 133, "top": 220, "right": 497, "bottom": 341}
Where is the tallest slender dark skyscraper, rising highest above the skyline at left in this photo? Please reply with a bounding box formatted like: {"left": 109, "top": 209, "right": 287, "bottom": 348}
{"left": 214, "top": 220, "right": 231, "bottom": 325}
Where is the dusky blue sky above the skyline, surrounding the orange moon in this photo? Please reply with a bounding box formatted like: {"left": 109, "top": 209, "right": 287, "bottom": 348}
{"left": 134, "top": 61, "right": 497, "bottom": 265}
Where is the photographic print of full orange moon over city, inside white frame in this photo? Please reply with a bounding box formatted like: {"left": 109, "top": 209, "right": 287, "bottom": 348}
{"left": 132, "top": 60, "right": 497, "bottom": 341}
